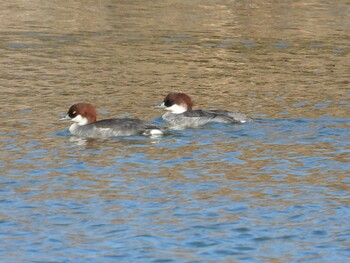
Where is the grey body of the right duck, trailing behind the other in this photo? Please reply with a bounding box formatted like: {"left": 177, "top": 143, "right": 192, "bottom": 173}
{"left": 162, "top": 110, "right": 251, "bottom": 127}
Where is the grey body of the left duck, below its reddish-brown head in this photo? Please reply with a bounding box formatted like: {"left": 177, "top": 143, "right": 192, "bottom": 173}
{"left": 69, "top": 119, "right": 159, "bottom": 137}
